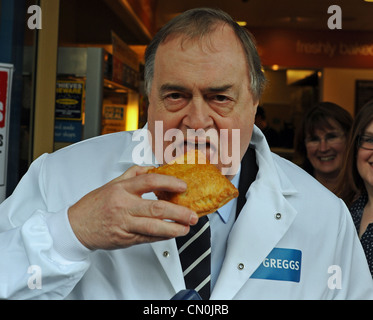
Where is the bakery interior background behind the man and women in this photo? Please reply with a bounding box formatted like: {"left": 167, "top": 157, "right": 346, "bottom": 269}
{"left": 0, "top": 0, "right": 373, "bottom": 195}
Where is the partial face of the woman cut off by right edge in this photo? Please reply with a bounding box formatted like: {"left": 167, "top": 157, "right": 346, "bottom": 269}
{"left": 356, "top": 121, "right": 373, "bottom": 189}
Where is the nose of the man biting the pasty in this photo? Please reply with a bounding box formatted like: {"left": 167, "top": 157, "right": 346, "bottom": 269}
{"left": 183, "top": 98, "right": 214, "bottom": 130}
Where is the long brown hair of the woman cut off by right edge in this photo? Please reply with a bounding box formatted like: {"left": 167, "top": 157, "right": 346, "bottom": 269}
{"left": 336, "top": 100, "right": 373, "bottom": 207}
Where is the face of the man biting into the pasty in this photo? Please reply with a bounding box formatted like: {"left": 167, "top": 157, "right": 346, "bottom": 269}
{"left": 148, "top": 25, "right": 257, "bottom": 176}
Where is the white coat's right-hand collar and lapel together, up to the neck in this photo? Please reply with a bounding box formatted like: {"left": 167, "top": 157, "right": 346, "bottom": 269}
{"left": 211, "top": 128, "right": 297, "bottom": 300}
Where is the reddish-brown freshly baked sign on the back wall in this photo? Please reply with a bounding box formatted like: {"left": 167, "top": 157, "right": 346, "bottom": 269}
{"left": 250, "top": 29, "right": 373, "bottom": 68}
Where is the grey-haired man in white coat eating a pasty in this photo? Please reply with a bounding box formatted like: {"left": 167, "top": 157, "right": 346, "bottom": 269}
{"left": 0, "top": 9, "right": 372, "bottom": 299}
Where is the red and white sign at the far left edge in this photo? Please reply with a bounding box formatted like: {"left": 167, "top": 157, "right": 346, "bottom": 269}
{"left": 0, "top": 63, "right": 13, "bottom": 202}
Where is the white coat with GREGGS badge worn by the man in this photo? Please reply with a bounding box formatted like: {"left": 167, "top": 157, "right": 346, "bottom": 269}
{"left": 0, "top": 128, "right": 373, "bottom": 299}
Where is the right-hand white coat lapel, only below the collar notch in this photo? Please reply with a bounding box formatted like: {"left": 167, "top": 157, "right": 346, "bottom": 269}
{"left": 211, "top": 184, "right": 296, "bottom": 300}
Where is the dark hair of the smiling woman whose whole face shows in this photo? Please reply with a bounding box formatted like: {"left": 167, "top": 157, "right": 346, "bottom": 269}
{"left": 295, "top": 102, "right": 352, "bottom": 174}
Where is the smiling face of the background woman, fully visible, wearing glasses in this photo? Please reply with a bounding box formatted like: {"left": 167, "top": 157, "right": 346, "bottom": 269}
{"left": 306, "top": 119, "right": 346, "bottom": 176}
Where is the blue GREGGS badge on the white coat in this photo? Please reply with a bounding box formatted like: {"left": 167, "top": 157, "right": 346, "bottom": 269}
{"left": 251, "top": 248, "right": 302, "bottom": 282}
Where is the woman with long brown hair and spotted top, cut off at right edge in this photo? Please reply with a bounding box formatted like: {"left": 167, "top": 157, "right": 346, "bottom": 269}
{"left": 337, "top": 100, "right": 373, "bottom": 276}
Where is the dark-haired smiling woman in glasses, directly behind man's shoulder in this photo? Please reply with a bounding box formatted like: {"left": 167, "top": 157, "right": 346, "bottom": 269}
{"left": 295, "top": 102, "right": 352, "bottom": 192}
